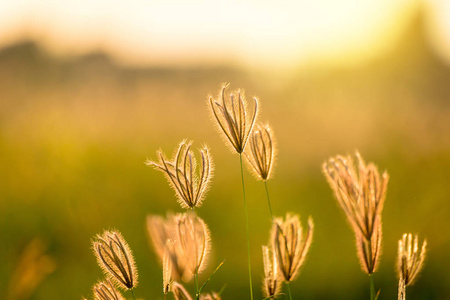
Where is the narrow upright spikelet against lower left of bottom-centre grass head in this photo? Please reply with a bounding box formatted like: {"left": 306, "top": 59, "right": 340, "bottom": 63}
{"left": 262, "top": 246, "right": 281, "bottom": 298}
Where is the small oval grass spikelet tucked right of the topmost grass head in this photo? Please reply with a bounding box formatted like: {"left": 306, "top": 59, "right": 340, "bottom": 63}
{"left": 245, "top": 124, "right": 276, "bottom": 180}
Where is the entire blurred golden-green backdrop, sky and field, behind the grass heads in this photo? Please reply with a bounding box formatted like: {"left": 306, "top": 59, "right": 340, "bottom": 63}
{"left": 0, "top": 0, "right": 450, "bottom": 300}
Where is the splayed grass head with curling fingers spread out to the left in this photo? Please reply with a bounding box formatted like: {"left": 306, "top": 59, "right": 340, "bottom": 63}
{"left": 146, "top": 140, "right": 213, "bottom": 208}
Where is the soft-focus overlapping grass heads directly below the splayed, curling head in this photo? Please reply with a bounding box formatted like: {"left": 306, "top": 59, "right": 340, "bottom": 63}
{"left": 147, "top": 212, "right": 211, "bottom": 282}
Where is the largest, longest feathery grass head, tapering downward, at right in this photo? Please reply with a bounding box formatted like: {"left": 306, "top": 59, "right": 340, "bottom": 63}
{"left": 323, "top": 152, "right": 389, "bottom": 274}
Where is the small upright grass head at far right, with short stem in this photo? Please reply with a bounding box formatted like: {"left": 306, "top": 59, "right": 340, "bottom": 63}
{"left": 397, "top": 233, "right": 427, "bottom": 300}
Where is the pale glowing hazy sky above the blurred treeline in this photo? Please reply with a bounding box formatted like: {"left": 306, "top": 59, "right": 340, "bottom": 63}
{"left": 0, "top": 0, "right": 450, "bottom": 66}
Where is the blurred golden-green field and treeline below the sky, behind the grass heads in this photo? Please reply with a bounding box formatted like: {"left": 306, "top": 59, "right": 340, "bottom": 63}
{"left": 0, "top": 12, "right": 450, "bottom": 300}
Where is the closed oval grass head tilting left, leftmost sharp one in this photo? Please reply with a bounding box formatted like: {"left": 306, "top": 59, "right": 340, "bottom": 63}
{"left": 92, "top": 230, "right": 138, "bottom": 290}
